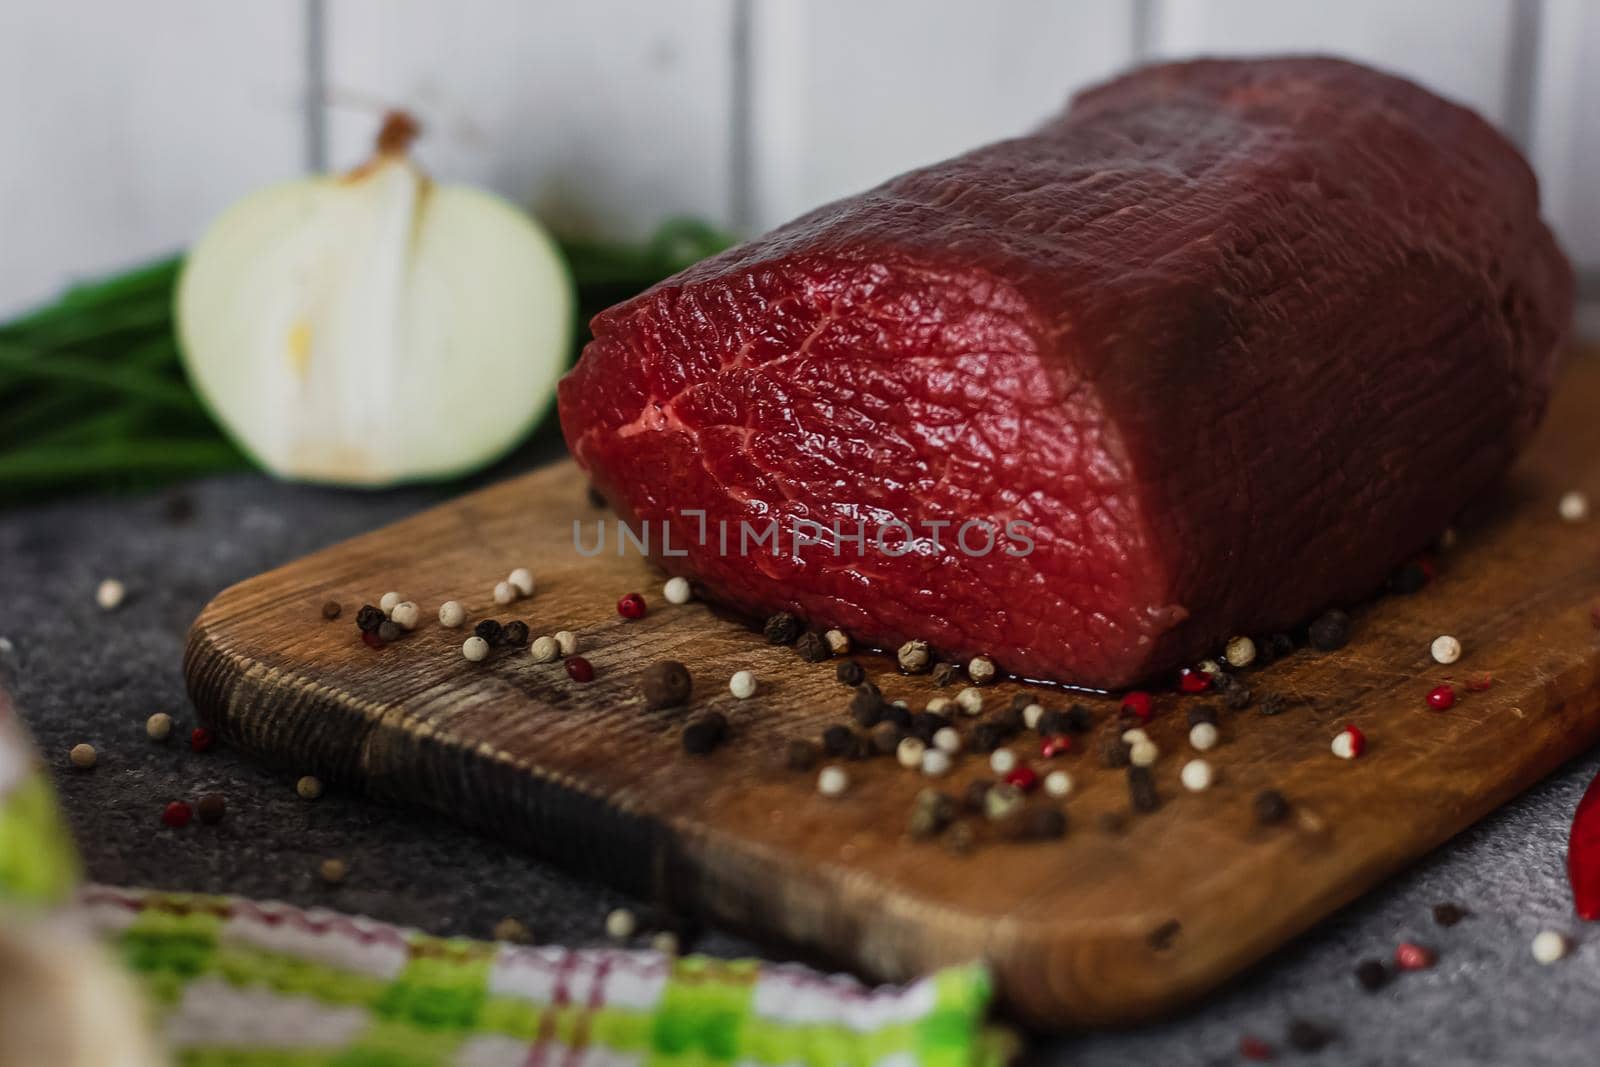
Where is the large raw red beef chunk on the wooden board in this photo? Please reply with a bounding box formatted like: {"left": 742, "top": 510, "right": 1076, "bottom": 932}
{"left": 560, "top": 58, "right": 1573, "bottom": 688}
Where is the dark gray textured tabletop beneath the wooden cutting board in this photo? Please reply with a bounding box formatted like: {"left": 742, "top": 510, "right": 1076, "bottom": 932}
{"left": 0, "top": 470, "right": 1600, "bottom": 1065}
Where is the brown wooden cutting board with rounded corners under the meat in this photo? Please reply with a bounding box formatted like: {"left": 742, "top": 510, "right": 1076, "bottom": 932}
{"left": 186, "top": 357, "right": 1600, "bottom": 1027}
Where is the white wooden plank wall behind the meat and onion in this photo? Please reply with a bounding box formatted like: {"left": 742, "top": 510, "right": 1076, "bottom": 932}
{"left": 0, "top": 0, "right": 1600, "bottom": 314}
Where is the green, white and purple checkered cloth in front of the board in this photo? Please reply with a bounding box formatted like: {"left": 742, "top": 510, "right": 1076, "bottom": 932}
{"left": 0, "top": 693, "right": 1010, "bottom": 1067}
